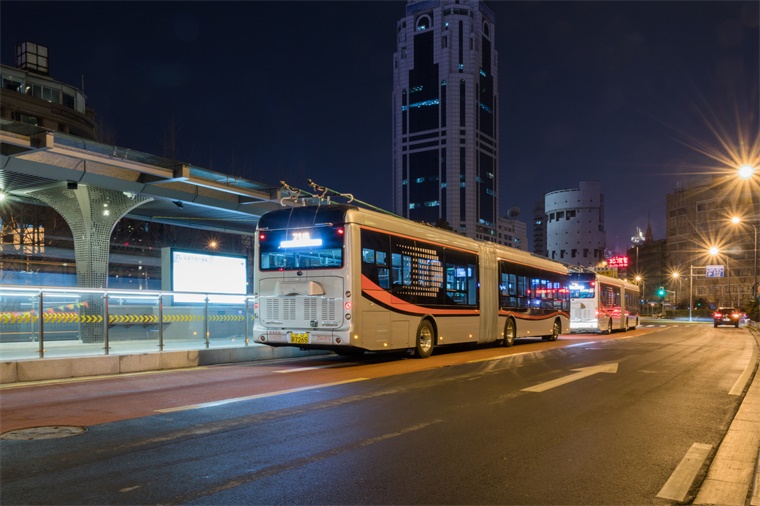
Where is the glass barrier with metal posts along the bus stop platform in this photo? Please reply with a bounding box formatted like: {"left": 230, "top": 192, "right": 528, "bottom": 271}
{"left": 0, "top": 286, "right": 254, "bottom": 361}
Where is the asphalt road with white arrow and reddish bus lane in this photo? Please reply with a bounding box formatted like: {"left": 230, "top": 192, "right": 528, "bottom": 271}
{"left": 0, "top": 324, "right": 754, "bottom": 505}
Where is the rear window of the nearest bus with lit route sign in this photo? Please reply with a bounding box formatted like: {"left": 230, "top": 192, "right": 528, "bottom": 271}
{"left": 259, "top": 226, "right": 345, "bottom": 271}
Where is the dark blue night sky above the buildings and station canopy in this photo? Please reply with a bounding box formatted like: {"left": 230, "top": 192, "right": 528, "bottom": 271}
{"left": 0, "top": 0, "right": 760, "bottom": 252}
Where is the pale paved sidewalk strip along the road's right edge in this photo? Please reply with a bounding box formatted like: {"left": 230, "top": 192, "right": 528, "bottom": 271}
{"left": 693, "top": 328, "right": 760, "bottom": 506}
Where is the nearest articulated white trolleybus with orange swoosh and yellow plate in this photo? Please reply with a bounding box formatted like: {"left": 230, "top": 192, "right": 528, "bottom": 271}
{"left": 253, "top": 204, "right": 570, "bottom": 358}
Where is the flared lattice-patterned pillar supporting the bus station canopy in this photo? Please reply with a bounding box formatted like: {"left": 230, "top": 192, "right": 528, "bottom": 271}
{"left": 29, "top": 185, "right": 153, "bottom": 343}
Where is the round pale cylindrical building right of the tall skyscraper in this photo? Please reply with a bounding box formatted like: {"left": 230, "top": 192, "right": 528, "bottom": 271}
{"left": 544, "top": 181, "right": 606, "bottom": 267}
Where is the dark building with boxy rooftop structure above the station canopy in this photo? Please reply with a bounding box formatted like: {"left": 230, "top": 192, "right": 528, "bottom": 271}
{"left": 0, "top": 42, "right": 96, "bottom": 140}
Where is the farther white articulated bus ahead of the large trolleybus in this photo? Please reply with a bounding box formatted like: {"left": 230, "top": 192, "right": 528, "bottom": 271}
{"left": 570, "top": 272, "right": 640, "bottom": 334}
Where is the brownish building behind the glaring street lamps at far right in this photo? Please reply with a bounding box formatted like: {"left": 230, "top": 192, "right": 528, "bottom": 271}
{"left": 665, "top": 174, "right": 760, "bottom": 307}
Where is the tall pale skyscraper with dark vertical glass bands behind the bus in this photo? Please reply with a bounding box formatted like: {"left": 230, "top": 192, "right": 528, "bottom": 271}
{"left": 393, "top": 0, "right": 499, "bottom": 242}
